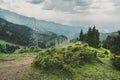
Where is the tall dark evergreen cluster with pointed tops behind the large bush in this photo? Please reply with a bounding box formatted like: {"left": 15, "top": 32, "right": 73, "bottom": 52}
{"left": 78, "top": 26, "right": 100, "bottom": 48}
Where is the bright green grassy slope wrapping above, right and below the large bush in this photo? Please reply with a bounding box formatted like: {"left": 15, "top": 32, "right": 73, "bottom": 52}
{"left": 21, "top": 42, "right": 120, "bottom": 80}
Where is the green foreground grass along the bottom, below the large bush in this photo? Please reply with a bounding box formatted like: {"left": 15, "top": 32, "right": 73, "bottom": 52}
{"left": 20, "top": 59, "right": 120, "bottom": 80}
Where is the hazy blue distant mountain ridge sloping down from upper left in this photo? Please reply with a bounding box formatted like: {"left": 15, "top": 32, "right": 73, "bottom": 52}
{"left": 0, "top": 9, "right": 88, "bottom": 37}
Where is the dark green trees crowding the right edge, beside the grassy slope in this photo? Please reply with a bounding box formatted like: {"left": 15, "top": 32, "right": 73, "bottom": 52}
{"left": 103, "top": 31, "right": 120, "bottom": 70}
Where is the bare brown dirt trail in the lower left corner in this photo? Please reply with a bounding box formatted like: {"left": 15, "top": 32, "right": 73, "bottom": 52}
{"left": 0, "top": 56, "right": 34, "bottom": 80}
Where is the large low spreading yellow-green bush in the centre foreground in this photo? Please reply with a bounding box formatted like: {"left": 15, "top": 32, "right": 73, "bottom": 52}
{"left": 32, "top": 45, "right": 97, "bottom": 76}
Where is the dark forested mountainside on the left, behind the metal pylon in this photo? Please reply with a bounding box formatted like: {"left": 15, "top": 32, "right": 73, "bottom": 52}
{"left": 0, "top": 18, "right": 67, "bottom": 48}
